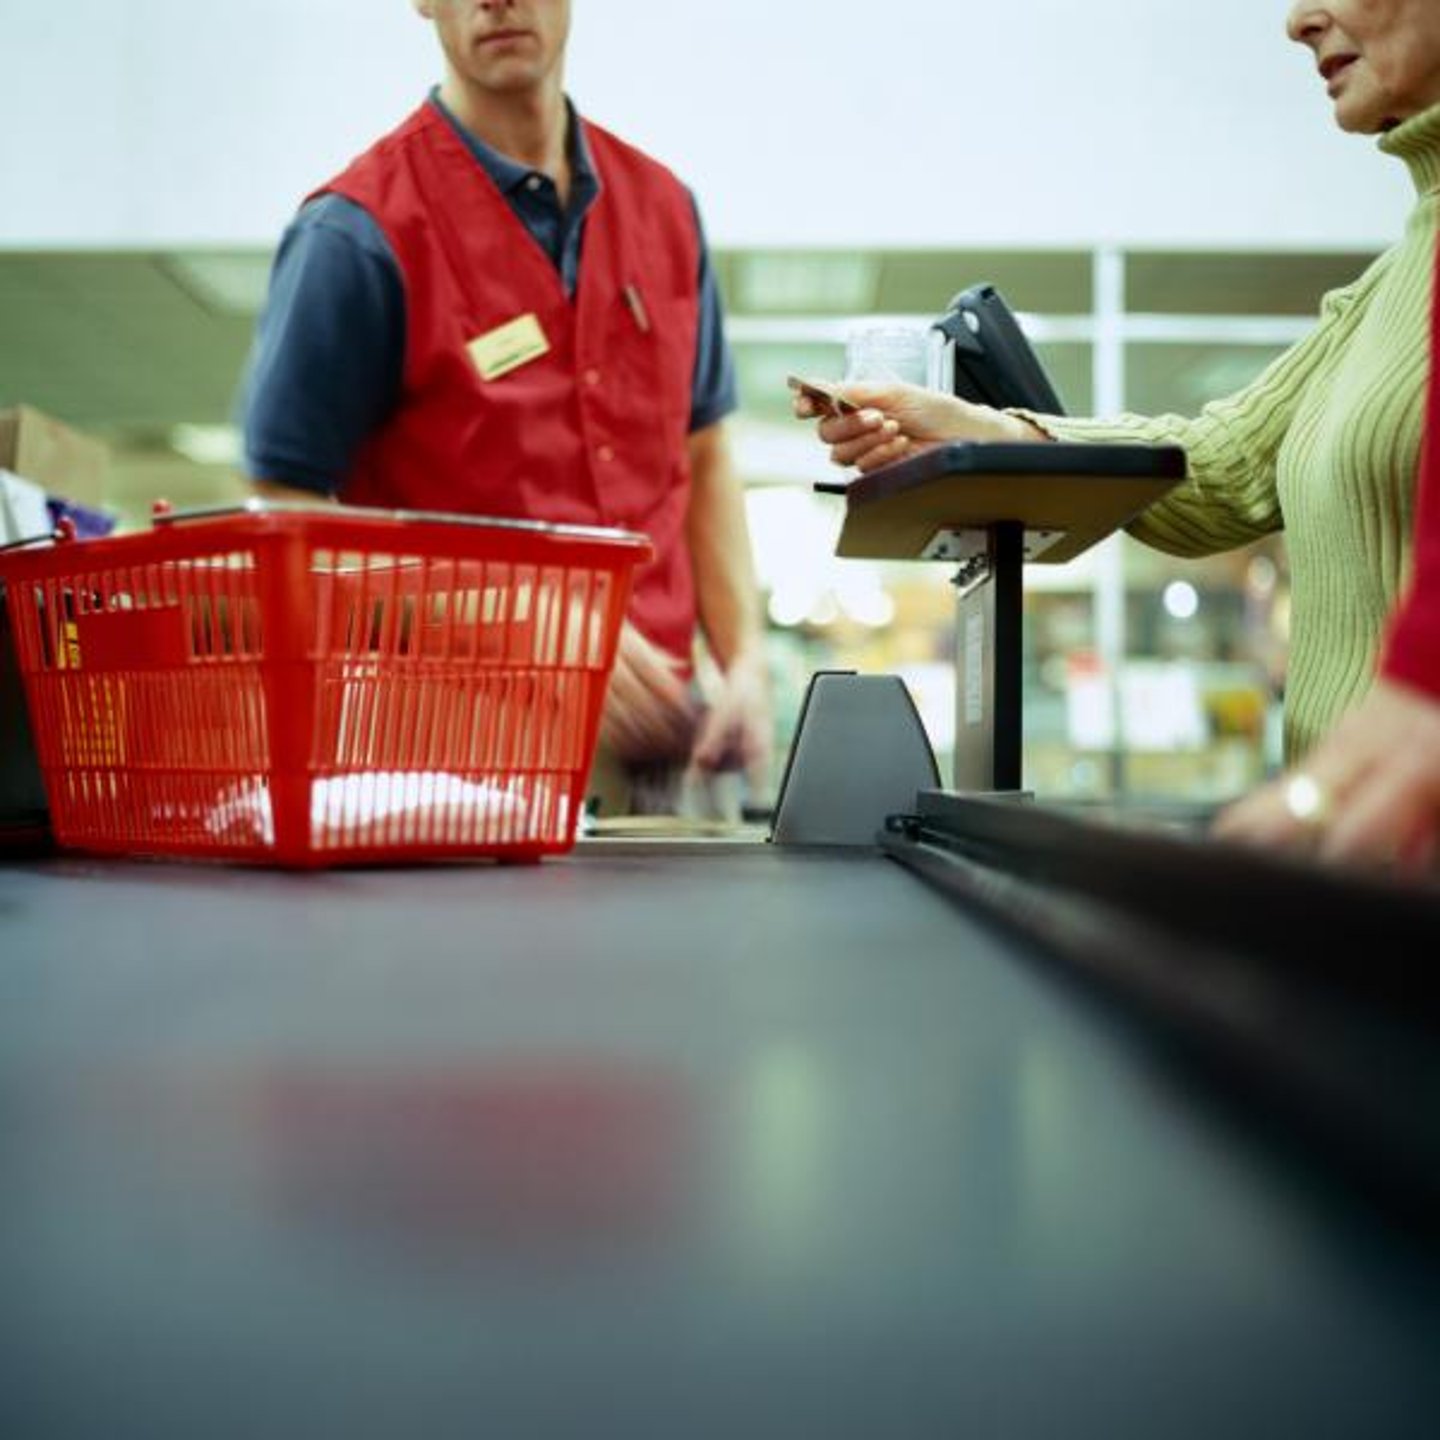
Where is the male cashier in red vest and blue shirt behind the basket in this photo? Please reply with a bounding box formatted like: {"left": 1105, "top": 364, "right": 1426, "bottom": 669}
{"left": 245, "top": 0, "right": 769, "bottom": 804}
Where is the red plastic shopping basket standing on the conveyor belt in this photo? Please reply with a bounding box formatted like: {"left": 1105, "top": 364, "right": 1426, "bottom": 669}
{"left": 0, "top": 503, "right": 649, "bottom": 865}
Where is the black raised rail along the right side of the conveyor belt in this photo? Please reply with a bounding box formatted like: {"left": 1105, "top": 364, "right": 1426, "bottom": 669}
{"left": 881, "top": 791, "right": 1440, "bottom": 1231}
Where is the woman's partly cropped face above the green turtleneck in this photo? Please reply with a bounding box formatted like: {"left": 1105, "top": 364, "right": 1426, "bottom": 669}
{"left": 1286, "top": 0, "right": 1440, "bottom": 134}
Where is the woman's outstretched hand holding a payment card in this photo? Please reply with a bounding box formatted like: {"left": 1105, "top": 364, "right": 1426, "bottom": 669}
{"left": 793, "top": 380, "right": 1047, "bottom": 472}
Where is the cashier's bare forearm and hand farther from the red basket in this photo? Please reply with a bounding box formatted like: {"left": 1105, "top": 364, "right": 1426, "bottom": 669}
{"left": 685, "top": 420, "right": 772, "bottom": 773}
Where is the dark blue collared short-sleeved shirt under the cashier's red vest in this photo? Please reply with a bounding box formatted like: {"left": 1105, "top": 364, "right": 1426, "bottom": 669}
{"left": 242, "top": 94, "right": 736, "bottom": 494}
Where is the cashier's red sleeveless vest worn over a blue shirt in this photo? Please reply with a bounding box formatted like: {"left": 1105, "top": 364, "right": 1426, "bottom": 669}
{"left": 317, "top": 104, "right": 700, "bottom": 658}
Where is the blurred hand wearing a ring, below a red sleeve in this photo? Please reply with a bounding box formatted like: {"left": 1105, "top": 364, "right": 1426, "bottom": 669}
{"left": 1214, "top": 680, "right": 1440, "bottom": 871}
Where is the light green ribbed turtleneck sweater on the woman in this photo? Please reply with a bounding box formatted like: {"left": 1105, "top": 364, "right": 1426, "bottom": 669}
{"left": 1021, "top": 107, "right": 1440, "bottom": 759}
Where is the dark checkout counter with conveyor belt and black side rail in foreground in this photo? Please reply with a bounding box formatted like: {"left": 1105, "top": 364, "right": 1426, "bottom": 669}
{"left": 0, "top": 446, "right": 1440, "bottom": 1440}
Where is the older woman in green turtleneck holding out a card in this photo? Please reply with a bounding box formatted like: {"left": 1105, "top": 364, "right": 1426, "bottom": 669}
{"left": 796, "top": 0, "right": 1440, "bottom": 757}
